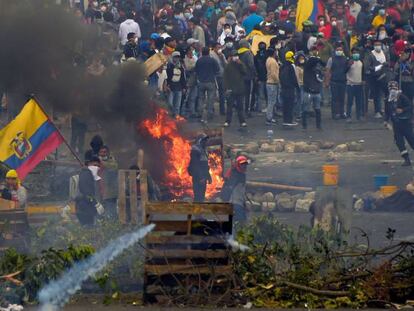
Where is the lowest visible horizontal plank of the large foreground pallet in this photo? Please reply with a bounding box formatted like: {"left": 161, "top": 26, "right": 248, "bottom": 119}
{"left": 144, "top": 265, "right": 232, "bottom": 275}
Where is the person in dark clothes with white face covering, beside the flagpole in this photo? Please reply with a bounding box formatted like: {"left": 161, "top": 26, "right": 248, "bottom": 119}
{"left": 75, "top": 152, "right": 103, "bottom": 226}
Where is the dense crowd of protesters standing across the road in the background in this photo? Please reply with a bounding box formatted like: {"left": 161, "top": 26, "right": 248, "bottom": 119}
{"left": 64, "top": 0, "right": 414, "bottom": 149}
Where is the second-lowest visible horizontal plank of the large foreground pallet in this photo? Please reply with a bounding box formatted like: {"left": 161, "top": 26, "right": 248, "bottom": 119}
{"left": 146, "top": 250, "right": 228, "bottom": 258}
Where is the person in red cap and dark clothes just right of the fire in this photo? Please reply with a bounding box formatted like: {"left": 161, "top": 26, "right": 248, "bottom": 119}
{"left": 220, "top": 156, "right": 248, "bottom": 223}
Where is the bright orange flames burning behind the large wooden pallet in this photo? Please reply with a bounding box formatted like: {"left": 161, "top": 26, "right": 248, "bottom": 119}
{"left": 140, "top": 109, "right": 223, "bottom": 198}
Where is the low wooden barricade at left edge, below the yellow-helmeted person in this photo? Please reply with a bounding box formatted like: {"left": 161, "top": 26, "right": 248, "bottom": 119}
{"left": 0, "top": 208, "right": 29, "bottom": 252}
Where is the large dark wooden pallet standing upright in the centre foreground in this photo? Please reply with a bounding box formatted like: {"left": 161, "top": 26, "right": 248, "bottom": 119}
{"left": 144, "top": 202, "right": 233, "bottom": 304}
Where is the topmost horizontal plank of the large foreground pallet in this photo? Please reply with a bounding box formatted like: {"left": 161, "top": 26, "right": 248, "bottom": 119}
{"left": 146, "top": 202, "right": 233, "bottom": 215}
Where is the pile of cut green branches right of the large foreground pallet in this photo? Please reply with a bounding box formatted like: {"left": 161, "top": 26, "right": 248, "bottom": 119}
{"left": 233, "top": 216, "right": 414, "bottom": 308}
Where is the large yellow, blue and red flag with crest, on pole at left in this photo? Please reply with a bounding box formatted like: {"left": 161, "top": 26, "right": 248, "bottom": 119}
{"left": 0, "top": 99, "right": 64, "bottom": 180}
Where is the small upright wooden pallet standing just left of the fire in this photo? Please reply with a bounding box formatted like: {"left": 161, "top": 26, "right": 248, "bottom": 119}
{"left": 118, "top": 170, "right": 142, "bottom": 224}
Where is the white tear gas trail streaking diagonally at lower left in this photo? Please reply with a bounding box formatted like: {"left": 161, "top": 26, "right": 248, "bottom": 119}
{"left": 39, "top": 224, "right": 155, "bottom": 311}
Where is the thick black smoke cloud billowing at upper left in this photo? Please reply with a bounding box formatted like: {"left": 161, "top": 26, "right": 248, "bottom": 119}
{"left": 0, "top": 0, "right": 154, "bottom": 165}
